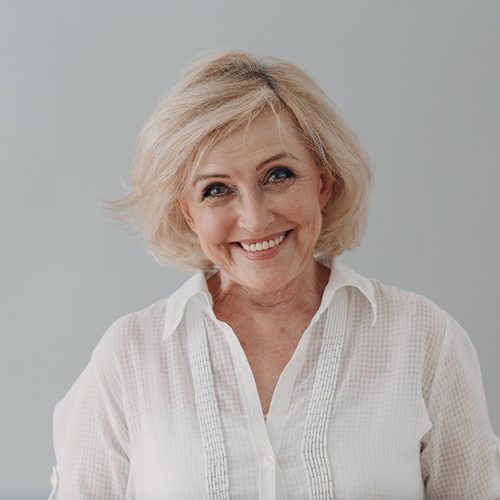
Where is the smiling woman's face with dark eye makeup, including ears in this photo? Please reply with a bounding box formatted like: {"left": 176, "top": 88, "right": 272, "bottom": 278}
{"left": 179, "top": 112, "right": 332, "bottom": 291}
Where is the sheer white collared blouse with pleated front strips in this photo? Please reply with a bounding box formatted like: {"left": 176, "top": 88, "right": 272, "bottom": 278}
{"left": 50, "top": 259, "right": 500, "bottom": 500}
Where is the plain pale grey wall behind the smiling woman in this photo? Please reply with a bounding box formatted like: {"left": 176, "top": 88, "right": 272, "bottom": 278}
{"left": 0, "top": 0, "right": 500, "bottom": 500}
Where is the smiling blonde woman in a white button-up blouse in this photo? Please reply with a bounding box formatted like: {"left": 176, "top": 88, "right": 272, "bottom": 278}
{"left": 47, "top": 52, "right": 500, "bottom": 500}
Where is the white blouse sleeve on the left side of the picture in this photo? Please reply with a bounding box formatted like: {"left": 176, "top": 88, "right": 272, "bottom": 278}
{"left": 50, "top": 344, "right": 129, "bottom": 500}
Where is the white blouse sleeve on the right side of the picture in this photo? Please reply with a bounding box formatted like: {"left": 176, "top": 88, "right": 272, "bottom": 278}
{"left": 421, "top": 312, "right": 500, "bottom": 500}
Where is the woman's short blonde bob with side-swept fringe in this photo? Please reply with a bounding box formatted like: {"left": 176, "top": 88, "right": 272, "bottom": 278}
{"left": 107, "top": 51, "right": 373, "bottom": 270}
